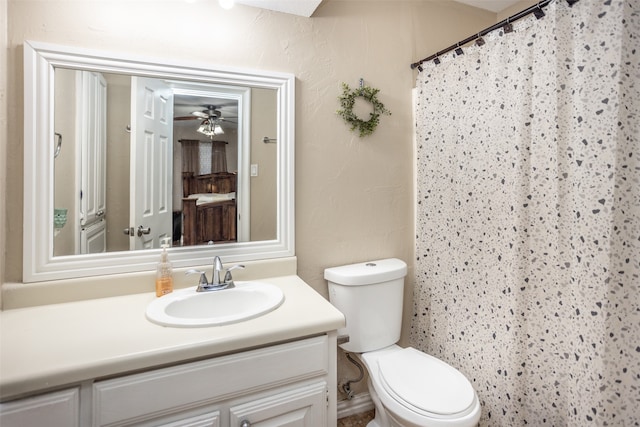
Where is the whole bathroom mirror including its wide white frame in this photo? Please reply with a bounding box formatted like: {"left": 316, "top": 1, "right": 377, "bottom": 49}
{"left": 23, "top": 42, "right": 295, "bottom": 282}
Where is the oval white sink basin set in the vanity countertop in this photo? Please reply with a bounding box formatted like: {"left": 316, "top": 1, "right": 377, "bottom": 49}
{"left": 146, "top": 281, "right": 284, "bottom": 328}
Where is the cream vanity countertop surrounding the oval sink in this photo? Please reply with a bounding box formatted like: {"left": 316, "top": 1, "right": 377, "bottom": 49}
{"left": 0, "top": 276, "right": 344, "bottom": 401}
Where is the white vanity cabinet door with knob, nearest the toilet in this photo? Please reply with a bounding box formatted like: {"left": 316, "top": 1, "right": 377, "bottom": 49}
{"left": 229, "top": 381, "right": 328, "bottom": 427}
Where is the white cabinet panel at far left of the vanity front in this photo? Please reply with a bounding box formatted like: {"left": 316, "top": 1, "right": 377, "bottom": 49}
{"left": 0, "top": 389, "right": 80, "bottom": 427}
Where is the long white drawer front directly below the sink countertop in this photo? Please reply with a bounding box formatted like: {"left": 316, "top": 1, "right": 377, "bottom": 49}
{"left": 93, "top": 336, "right": 329, "bottom": 426}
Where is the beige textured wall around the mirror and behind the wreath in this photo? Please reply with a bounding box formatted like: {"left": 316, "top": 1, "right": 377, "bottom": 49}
{"left": 0, "top": 0, "right": 495, "bottom": 404}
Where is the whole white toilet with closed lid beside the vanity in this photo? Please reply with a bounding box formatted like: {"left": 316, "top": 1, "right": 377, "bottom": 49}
{"left": 324, "top": 258, "right": 480, "bottom": 427}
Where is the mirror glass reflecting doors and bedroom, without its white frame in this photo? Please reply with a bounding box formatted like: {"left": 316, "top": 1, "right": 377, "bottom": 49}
{"left": 54, "top": 68, "right": 277, "bottom": 256}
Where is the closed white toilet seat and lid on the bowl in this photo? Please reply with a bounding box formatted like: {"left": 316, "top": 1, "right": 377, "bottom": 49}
{"left": 363, "top": 347, "right": 478, "bottom": 421}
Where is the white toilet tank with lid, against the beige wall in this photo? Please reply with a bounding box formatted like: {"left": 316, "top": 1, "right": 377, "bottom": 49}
{"left": 324, "top": 258, "right": 407, "bottom": 353}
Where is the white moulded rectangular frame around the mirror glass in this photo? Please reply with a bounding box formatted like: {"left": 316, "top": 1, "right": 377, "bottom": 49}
{"left": 23, "top": 41, "right": 295, "bottom": 283}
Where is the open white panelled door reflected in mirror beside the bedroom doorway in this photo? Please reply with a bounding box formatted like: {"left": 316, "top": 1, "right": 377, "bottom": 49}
{"left": 129, "top": 77, "right": 173, "bottom": 249}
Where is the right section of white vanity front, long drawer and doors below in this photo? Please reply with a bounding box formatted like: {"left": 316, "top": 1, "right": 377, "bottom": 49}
{"left": 92, "top": 335, "right": 335, "bottom": 427}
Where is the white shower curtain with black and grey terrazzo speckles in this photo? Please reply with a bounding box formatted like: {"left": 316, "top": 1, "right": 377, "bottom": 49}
{"left": 410, "top": 0, "right": 640, "bottom": 427}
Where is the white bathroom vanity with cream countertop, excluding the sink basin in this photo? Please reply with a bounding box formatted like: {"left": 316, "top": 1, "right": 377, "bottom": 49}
{"left": 0, "top": 272, "right": 344, "bottom": 427}
